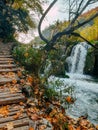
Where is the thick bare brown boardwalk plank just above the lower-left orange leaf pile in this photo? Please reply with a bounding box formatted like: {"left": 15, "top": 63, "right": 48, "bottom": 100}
{"left": 0, "top": 96, "right": 26, "bottom": 105}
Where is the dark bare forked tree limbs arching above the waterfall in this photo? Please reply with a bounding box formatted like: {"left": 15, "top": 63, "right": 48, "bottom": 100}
{"left": 38, "top": 0, "right": 98, "bottom": 51}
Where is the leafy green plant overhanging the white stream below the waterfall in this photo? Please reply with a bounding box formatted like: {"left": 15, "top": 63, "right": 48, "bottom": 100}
{"left": 44, "top": 77, "right": 74, "bottom": 103}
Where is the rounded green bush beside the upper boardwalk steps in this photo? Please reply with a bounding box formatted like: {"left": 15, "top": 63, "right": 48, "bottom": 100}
{"left": 13, "top": 45, "right": 41, "bottom": 75}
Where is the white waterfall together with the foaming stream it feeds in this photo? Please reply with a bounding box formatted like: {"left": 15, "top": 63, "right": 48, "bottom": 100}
{"left": 49, "top": 42, "right": 98, "bottom": 124}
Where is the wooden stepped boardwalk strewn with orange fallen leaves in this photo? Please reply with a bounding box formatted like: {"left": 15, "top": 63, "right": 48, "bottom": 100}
{"left": 0, "top": 43, "right": 29, "bottom": 130}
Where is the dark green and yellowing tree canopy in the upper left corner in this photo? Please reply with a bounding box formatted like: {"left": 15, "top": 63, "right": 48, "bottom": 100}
{"left": 0, "top": 0, "right": 44, "bottom": 38}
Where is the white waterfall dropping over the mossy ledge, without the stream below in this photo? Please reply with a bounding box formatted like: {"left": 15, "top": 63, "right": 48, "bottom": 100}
{"left": 66, "top": 42, "right": 89, "bottom": 74}
